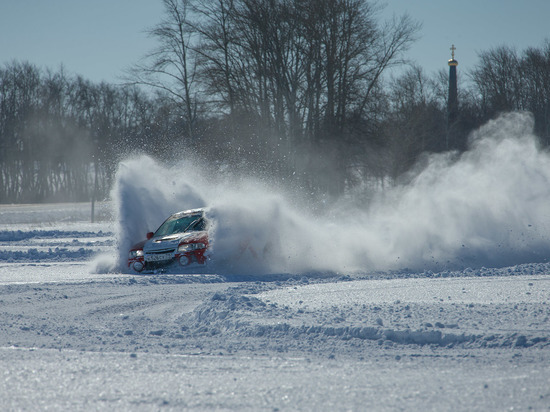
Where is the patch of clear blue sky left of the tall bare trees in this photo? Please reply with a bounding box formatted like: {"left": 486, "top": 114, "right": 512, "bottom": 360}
{"left": 0, "top": 0, "right": 163, "bottom": 83}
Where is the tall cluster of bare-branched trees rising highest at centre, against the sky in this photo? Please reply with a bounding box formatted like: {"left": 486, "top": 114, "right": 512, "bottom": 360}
{"left": 192, "top": 0, "right": 419, "bottom": 192}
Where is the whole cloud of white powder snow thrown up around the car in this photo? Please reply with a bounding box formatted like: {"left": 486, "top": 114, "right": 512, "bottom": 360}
{"left": 109, "top": 113, "right": 550, "bottom": 274}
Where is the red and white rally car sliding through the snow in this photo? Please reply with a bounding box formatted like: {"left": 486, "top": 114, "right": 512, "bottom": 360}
{"left": 128, "top": 209, "right": 208, "bottom": 273}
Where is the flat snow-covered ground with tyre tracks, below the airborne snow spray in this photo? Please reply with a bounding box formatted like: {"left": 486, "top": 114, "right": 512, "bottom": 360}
{"left": 0, "top": 204, "right": 550, "bottom": 411}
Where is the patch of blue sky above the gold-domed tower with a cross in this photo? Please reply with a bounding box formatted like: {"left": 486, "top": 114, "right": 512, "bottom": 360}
{"left": 384, "top": 0, "right": 550, "bottom": 77}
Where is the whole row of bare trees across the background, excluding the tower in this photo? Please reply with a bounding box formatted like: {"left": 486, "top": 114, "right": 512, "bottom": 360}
{"left": 0, "top": 0, "right": 550, "bottom": 202}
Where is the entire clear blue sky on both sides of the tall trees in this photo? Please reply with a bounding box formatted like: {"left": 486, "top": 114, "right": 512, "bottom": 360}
{"left": 0, "top": 0, "right": 550, "bottom": 83}
